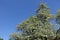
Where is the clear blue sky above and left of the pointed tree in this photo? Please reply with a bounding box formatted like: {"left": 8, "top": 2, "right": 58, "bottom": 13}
{"left": 0, "top": 0, "right": 60, "bottom": 40}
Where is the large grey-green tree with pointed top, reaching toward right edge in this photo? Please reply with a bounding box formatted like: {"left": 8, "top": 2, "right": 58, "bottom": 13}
{"left": 9, "top": 3, "right": 60, "bottom": 40}
